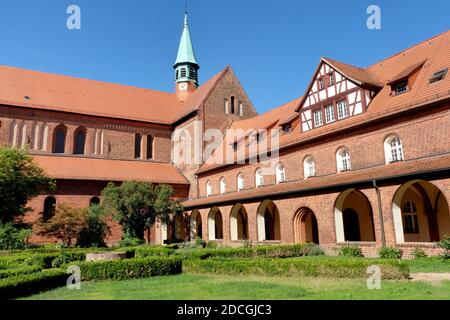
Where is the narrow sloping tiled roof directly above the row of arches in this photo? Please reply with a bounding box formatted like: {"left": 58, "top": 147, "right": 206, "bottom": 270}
{"left": 183, "top": 154, "right": 450, "bottom": 209}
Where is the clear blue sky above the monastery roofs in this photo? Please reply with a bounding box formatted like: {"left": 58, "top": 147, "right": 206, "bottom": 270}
{"left": 0, "top": 0, "right": 450, "bottom": 112}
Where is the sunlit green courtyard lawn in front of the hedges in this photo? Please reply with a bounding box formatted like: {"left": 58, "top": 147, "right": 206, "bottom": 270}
{"left": 23, "top": 274, "right": 450, "bottom": 300}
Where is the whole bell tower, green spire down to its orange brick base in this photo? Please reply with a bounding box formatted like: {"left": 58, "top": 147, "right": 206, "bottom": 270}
{"left": 173, "top": 11, "right": 200, "bottom": 101}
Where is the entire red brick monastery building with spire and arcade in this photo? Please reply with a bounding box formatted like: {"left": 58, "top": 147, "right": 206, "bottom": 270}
{"left": 0, "top": 13, "right": 450, "bottom": 255}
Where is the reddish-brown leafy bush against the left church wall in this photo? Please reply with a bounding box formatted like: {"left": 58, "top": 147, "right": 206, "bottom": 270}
{"left": 38, "top": 204, "right": 88, "bottom": 247}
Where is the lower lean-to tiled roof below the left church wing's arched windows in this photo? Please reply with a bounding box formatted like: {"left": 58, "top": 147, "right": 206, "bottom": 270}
{"left": 34, "top": 156, "right": 189, "bottom": 184}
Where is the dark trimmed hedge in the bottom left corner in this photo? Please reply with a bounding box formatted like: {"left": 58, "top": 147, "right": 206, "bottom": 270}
{"left": 0, "top": 270, "right": 68, "bottom": 300}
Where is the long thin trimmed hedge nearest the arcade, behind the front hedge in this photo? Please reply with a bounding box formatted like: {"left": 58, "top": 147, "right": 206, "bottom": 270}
{"left": 184, "top": 244, "right": 323, "bottom": 260}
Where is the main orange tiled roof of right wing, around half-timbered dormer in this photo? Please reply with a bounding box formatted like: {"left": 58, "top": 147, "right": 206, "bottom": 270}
{"left": 198, "top": 31, "right": 450, "bottom": 174}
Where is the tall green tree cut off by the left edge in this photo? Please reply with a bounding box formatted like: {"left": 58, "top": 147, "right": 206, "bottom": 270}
{"left": 0, "top": 148, "right": 55, "bottom": 223}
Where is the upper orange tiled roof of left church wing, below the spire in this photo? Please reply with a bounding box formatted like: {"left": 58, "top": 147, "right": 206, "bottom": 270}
{"left": 0, "top": 66, "right": 229, "bottom": 124}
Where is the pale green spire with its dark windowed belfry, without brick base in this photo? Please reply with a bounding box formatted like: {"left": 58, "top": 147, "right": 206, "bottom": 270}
{"left": 173, "top": 11, "right": 200, "bottom": 84}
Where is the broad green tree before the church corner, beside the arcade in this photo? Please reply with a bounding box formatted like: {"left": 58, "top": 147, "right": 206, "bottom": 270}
{"left": 102, "top": 181, "right": 183, "bottom": 240}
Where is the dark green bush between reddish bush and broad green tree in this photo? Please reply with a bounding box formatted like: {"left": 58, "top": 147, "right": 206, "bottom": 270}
{"left": 77, "top": 205, "right": 110, "bottom": 248}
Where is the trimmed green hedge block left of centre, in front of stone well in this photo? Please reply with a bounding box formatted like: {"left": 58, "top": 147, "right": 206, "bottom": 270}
{"left": 78, "top": 257, "right": 182, "bottom": 281}
